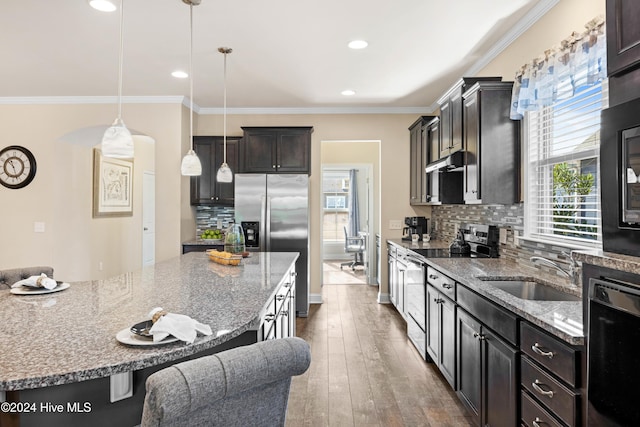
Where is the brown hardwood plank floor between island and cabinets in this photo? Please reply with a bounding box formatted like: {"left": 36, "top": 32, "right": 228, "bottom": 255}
{"left": 286, "top": 285, "right": 471, "bottom": 427}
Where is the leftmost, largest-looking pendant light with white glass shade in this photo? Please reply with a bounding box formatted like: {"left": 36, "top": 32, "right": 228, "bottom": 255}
{"left": 102, "top": 0, "right": 133, "bottom": 158}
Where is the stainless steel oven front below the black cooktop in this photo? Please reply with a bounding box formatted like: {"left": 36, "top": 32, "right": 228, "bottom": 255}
{"left": 404, "top": 253, "right": 427, "bottom": 360}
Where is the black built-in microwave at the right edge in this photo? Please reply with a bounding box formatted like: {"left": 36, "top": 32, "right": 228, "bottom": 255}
{"left": 600, "top": 99, "right": 640, "bottom": 256}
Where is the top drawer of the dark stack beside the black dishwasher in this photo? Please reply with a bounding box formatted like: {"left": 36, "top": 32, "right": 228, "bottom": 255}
{"left": 520, "top": 322, "right": 579, "bottom": 387}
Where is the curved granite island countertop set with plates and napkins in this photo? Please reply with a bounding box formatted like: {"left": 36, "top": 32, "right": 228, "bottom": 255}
{"left": 0, "top": 252, "right": 298, "bottom": 390}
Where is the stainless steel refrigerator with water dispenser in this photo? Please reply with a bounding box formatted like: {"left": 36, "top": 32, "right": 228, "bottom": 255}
{"left": 234, "top": 174, "right": 309, "bottom": 317}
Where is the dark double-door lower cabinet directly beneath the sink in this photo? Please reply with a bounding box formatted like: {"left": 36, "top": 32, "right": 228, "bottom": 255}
{"left": 457, "top": 307, "right": 519, "bottom": 427}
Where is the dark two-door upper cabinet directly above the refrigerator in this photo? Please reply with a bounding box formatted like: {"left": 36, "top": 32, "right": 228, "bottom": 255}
{"left": 239, "top": 126, "right": 313, "bottom": 174}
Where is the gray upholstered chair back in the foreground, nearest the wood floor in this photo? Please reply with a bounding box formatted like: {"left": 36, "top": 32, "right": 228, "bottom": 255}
{"left": 141, "top": 338, "right": 311, "bottom": 427}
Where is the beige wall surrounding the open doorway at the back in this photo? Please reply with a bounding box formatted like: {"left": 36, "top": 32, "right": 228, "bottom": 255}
{"left": 197, "top": 114, "right": 416, "bottom": 298}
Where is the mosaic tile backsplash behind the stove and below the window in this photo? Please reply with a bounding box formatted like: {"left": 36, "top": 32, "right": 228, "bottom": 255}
{"left": 431, "top": 203, "right": 569, "bottom": 280}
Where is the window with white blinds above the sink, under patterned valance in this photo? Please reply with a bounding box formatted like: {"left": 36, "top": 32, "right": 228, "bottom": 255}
{"left": 525, "top": 81, "right": 608, "bottom": 246}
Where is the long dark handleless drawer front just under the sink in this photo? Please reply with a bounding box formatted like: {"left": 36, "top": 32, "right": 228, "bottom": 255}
{"left": 456, "top": 286, "right": 518, "bottom": 347}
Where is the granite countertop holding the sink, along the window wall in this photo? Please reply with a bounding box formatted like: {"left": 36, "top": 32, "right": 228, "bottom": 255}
{"left": 388, "top": 239, "right": 584, "bottom": 345}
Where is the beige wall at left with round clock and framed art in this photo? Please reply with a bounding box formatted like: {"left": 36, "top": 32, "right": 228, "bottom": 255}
{"left": 0, "top": 104, "right": 188, "bottom": 281}
